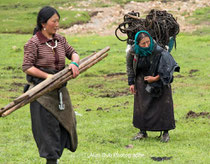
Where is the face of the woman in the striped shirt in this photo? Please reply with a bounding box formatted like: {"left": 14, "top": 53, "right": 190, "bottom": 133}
{"left": 43, "top": 14, "right": 59, "bottom": 35}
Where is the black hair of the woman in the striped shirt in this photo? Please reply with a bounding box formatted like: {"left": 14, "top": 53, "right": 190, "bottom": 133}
{"left": 33, "top": 6, "right": 60, "bottom": 35}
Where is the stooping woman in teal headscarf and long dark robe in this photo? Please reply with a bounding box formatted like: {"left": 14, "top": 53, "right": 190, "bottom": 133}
{"left": 127, "top": 31, "right": 179, "bottom": 142}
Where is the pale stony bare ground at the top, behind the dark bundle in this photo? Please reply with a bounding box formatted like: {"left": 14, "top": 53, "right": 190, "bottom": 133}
{"left": 59, "top": 0, "right": 210, "bottom": 35}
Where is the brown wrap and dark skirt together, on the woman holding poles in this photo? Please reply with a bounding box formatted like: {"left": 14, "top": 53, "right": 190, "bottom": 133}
{"left": 27, "top": 67, "right": 78, "bottom": 159}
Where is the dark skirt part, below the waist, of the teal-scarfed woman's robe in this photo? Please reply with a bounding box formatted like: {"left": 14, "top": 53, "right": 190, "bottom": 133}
{"left": 133, "top": 74, "right": 175, "bottom": 131}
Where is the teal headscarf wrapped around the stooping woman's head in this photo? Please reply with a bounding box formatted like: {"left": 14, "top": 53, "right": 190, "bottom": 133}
{"left": 134, "top": 30, "right": 154, "bottom": 56}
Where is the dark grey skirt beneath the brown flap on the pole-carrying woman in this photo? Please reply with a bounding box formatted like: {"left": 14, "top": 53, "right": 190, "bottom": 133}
{"left": 30, "top": 101, "right": 70, "bottom": 159}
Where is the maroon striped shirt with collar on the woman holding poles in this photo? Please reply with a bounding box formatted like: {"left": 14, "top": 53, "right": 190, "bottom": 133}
{"left": 22, "top": 31, "right": 76, "bottom": 72}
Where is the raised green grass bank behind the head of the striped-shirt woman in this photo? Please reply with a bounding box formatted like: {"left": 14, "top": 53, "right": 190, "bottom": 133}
{"left": 0, "top": 0, "right": 90, "bottom": 33}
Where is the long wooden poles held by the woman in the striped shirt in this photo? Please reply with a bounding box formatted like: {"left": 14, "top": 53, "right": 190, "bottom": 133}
{"left": 0, "top": 47, "right": 110, "bottom": 117}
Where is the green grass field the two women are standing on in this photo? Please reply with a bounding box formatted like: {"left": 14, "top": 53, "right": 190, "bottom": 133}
{"left": 0, "top": 34, "right": 210, "bottom": 164}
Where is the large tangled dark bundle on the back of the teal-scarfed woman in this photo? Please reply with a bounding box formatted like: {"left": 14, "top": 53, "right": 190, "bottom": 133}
{"left": 115, "top": 9, "right": 179, "bottom": 48}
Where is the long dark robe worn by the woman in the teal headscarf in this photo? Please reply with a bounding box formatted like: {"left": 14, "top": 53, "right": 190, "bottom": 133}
{"left": 127, "top": 45, "right": 175, "bottom": 131}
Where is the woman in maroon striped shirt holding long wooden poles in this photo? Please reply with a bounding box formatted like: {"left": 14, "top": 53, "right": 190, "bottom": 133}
{"left": 22, "top": 6, "right": 79, "bottom": 164}
